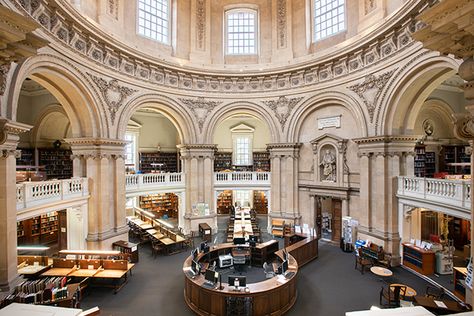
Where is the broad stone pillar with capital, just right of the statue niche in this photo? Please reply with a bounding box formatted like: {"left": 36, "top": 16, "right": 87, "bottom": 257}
{"left": 351, "top": 136, "right": 417, "bottom": 264}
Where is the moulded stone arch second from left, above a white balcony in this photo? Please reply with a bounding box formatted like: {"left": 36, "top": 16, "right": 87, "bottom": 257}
{"left": 117, "top": 93, "right": 197, "bottom": 144}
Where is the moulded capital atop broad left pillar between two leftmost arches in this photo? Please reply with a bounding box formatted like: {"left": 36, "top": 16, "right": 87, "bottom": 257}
{"left": 65, "top": 137, "right": 129, "bottom": 159}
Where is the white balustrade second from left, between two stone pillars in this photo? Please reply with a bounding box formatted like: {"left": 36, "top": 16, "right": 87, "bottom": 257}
{"left": 125, "top": 173, "right": 184, "bottom": 191}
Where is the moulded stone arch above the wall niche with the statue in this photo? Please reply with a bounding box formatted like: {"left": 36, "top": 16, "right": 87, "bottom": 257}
{"left": 287, "top": 91, "right": 368, "bottom": 142}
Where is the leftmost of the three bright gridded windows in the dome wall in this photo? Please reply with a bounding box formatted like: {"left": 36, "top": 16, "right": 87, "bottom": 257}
{"left": 138, "top": 0, "right": 170, "bottom": 44}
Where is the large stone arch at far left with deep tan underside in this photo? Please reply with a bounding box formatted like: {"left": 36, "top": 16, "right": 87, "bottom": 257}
{"left": 7, "top": 54, "right": 103, "bottom": 137}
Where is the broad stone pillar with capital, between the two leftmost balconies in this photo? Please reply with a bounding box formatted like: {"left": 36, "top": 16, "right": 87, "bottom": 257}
{"left": 66, "top": 138, "right": 128, "bottom": 249}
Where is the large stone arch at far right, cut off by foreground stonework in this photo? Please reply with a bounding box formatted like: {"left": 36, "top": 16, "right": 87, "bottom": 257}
{"left": 376, "top": 51, "right": 459, "bottom": 135}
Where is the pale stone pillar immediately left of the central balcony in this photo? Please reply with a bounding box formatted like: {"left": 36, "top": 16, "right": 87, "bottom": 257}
{"left": 178, "top": 144, "right": 217, "bottom": 233}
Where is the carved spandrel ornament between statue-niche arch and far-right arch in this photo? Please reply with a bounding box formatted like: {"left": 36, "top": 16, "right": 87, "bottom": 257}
{"left": 348, "top": 69, "right": 395, "bottom": 122}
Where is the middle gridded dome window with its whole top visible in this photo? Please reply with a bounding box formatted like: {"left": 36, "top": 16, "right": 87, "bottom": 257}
{"left": 225, "top": 9, "right": 257, "bottom": 55}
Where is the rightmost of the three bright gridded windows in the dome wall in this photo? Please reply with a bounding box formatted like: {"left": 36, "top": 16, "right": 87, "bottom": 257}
{"left": 314, "top": 0, "right": 346, "bottom": 41}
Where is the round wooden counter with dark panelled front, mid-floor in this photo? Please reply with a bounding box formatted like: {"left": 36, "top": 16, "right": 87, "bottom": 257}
{"left": 183, "top": 244, "right": 298, "bottom": 316}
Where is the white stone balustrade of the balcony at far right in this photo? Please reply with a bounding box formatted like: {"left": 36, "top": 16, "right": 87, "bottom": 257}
{"left": 397, "top": 177, "right": 471, "bottom": 210}
